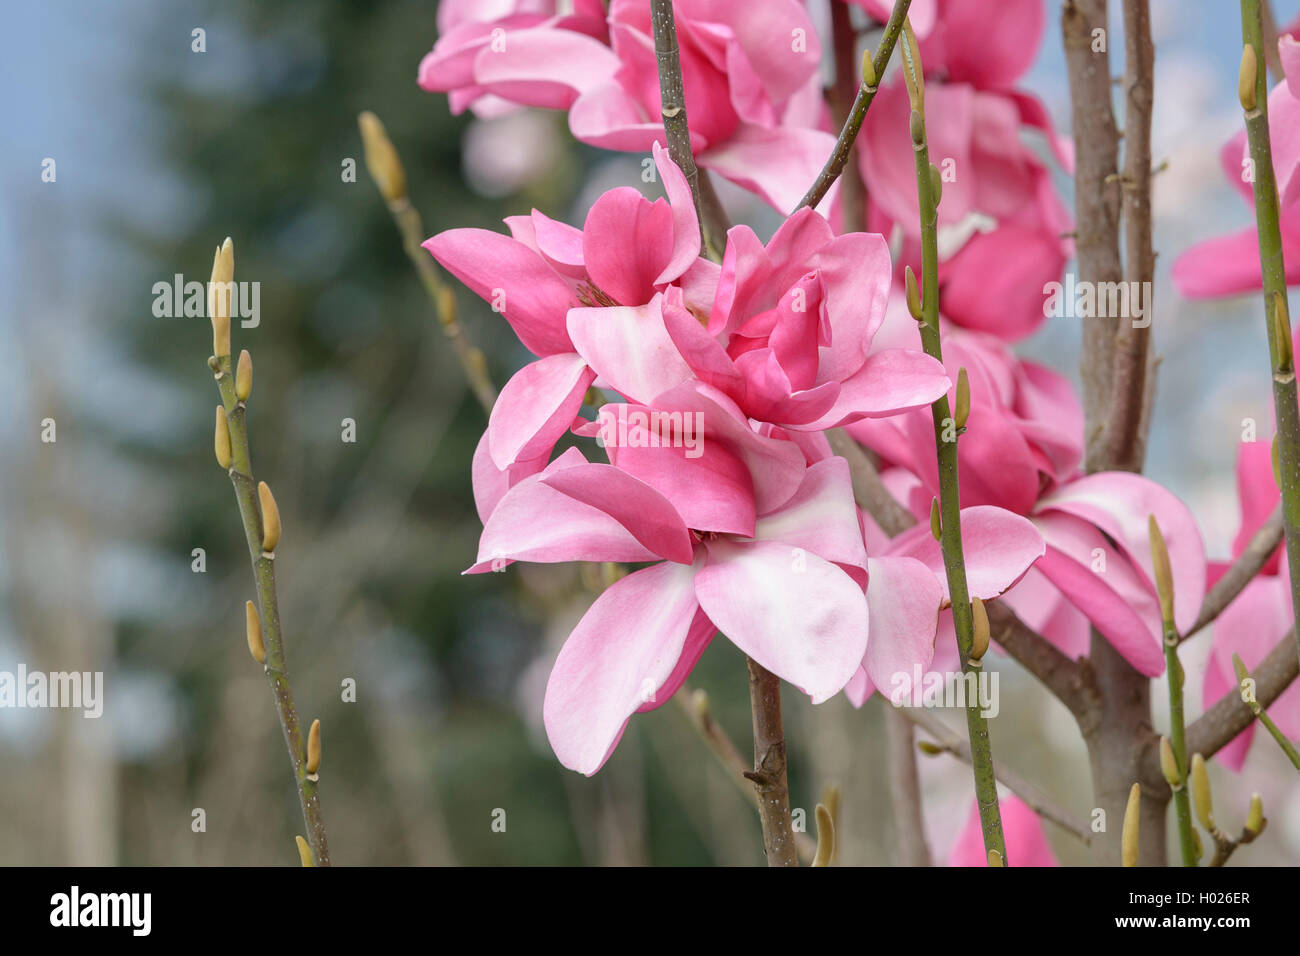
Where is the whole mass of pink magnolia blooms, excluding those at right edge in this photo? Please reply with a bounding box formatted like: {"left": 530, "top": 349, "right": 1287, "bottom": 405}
{"left": 419, "top": 0, "right": 1227, "bottom": 842}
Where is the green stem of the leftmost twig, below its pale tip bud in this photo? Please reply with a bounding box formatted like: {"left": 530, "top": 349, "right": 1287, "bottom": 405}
{"left": 215, "top": 355, "right": 330, "bottom": 866}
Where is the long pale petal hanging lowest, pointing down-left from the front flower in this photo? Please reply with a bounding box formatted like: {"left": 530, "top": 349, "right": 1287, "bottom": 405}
{"left": 542, "top": 563, "right": 698, "bottom": 777}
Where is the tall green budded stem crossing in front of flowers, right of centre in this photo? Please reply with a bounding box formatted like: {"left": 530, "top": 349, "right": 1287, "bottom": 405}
{"left": 902, "top": 35, "right": 1011, "bottom": 866}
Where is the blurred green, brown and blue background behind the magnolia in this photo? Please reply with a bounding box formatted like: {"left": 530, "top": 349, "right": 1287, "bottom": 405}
{"left": 0, "top": 0, "right": 1300, "bottom": 865}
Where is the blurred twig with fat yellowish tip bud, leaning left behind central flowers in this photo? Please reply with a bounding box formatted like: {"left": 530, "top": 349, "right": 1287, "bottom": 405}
{"left": 358, "top": 112, "right": 497, "bottom": 415}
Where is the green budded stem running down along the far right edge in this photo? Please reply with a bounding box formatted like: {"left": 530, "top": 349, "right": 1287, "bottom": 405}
{"left": 1242, "top": 0, "right": 1300, "bottom": 671}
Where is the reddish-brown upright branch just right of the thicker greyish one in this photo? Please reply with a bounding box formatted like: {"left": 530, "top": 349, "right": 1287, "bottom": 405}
{"left": 1100, "top": 0, "right": 1156, "bottom": 471}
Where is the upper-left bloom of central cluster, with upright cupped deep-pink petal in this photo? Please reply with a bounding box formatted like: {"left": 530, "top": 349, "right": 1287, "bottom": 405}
{"left": 424, "top": 143, "right": 718, "bottom": 477}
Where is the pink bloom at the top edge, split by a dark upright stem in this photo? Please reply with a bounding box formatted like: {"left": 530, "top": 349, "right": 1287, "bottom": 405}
{"left": 420, "top": 0, "right": 835, "bottom": 212}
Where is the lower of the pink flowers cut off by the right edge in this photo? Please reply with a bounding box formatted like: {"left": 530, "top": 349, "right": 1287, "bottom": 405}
{"left": 1201, "top": 441, "right": 1300, "bottom": 770}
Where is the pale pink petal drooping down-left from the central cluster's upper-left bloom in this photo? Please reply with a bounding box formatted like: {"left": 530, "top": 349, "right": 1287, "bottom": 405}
{"left": 488, "top": 352, "right": 595, "bottom": 468}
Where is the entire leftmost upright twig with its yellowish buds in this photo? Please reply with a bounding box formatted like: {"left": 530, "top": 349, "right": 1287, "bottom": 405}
{"left": 208, "top": 239, "right": 330, "bottom": 866}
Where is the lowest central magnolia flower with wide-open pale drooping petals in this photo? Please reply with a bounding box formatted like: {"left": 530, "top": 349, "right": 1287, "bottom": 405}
{"left": 469, "top": 385, "right": 941, "bottom": 774}
